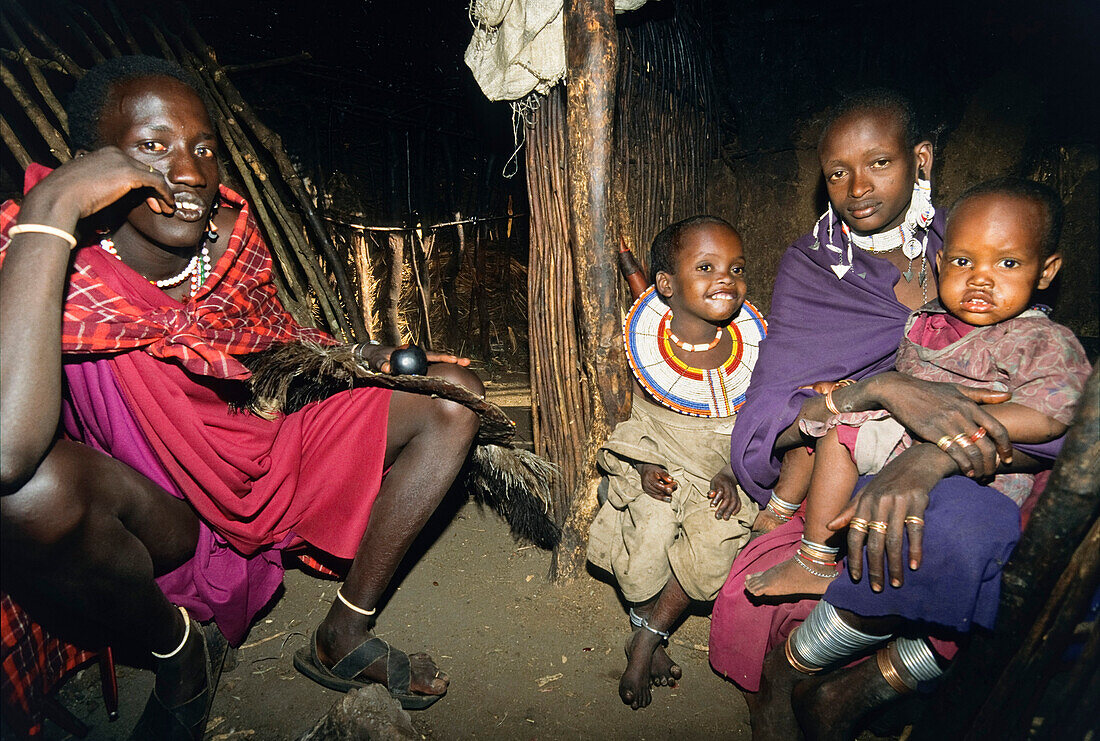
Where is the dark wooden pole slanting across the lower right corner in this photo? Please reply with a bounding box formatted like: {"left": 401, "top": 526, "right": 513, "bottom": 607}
{"left": 912, "top": 367, "right": 1100, "bottom": 741}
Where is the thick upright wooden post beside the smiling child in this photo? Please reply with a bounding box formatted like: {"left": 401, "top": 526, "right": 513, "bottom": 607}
{"left": 551, "top": 0, "right": 629, "bottom": 579}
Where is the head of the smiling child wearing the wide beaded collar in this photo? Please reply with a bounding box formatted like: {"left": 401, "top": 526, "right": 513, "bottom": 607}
{"left": 650, "top": 215, "right": 747, "bottom": 324}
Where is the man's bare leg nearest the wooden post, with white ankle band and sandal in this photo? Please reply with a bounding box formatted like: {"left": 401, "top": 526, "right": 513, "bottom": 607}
{"left": 317, "top": 365, "right": 484, "bottom": 695}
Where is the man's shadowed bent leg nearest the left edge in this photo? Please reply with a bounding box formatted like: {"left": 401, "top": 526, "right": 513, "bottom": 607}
{"left": 0, "top": 441, "right": 206, "bottom": 707}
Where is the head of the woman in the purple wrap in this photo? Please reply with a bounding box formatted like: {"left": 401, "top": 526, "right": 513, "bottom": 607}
{"left": 817, "top": 88, "right": 932, "bottom": 234}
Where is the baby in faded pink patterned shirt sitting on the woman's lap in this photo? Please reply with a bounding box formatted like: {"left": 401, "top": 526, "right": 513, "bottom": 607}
{"left": 745, "top": 178, "right": 1090, "bottom": 596}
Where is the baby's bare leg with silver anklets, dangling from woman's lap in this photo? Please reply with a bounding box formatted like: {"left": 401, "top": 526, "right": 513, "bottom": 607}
{"left": 745, "top": 429, "right": 859, "bottom": 597}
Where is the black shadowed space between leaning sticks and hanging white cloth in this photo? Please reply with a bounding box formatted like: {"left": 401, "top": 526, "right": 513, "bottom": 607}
{"left": 187, "top": 0, "right": 524, "bottom": 225}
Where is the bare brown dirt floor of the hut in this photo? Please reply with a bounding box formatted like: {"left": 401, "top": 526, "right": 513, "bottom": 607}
{"left": 19, "top": 377, "right": 749, "bottom": 741}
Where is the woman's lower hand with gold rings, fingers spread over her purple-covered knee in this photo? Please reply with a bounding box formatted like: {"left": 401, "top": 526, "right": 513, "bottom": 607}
{"left": 828, "top": 443, "right": 958, "bottom": 591}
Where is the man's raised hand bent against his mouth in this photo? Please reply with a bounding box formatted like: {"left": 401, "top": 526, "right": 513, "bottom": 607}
{"left": 19, "top": 146, "right": 176, "bottom": 232}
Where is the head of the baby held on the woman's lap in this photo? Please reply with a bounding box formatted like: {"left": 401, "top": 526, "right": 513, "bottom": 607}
{"left": 937, "top": 178, "right": 1063, "bottom": 327}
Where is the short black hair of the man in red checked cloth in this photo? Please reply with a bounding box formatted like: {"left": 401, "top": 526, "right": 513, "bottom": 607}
{"left": 65, "top": 55, "right": 206, "bottom": 152}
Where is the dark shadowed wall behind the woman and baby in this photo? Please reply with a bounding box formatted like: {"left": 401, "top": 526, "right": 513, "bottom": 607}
{"left": 699, "top": 0, "right": 1100, "bottom": 338}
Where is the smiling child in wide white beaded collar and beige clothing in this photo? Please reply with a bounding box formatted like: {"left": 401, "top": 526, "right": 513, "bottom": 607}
{"left": 589, "top": 215, "right": 765, "bottom": 709}
